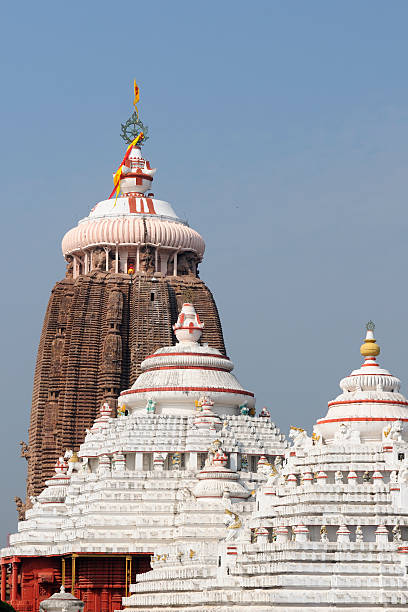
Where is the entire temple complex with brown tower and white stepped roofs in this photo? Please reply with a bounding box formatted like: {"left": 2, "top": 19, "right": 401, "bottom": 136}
{"left": 0, "top": 85, "right": 408, "bottom": 612}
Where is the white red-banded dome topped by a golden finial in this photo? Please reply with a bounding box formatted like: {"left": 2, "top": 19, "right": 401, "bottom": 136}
{"left": 316, "top": 322, "right": 408, "bottom": 444}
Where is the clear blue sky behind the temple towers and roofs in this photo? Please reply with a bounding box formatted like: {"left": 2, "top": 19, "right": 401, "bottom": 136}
{"left": 0, "top": 0, "right": 408, "bottom": 533}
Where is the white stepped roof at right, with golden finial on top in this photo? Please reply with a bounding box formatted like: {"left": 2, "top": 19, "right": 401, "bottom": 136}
{"left": 124, "top": 329, "right": 408, "bottom": 612}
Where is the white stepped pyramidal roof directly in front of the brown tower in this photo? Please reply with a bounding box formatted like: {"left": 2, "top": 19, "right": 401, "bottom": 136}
{"left": 1, "top": 303, "right": 287, "bottom": 612}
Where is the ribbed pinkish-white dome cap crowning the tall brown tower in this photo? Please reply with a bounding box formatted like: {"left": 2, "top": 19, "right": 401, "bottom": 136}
{"left": 61, "top": 146, "right": 205, "bottom": 278}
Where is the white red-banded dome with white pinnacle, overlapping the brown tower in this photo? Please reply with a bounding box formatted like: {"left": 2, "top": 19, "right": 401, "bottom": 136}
{"left": 119, "top": 303, "right": 255, "bottom": 415}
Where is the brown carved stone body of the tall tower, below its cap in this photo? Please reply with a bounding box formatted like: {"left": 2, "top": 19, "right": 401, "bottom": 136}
{"left": 26, "top": 272, "right": 225, "bottom": 496}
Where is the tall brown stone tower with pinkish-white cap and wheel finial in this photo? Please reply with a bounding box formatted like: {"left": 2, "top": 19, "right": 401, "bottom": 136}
{"left": 22, "top": 116, "right": 225, "bottom": 498}
